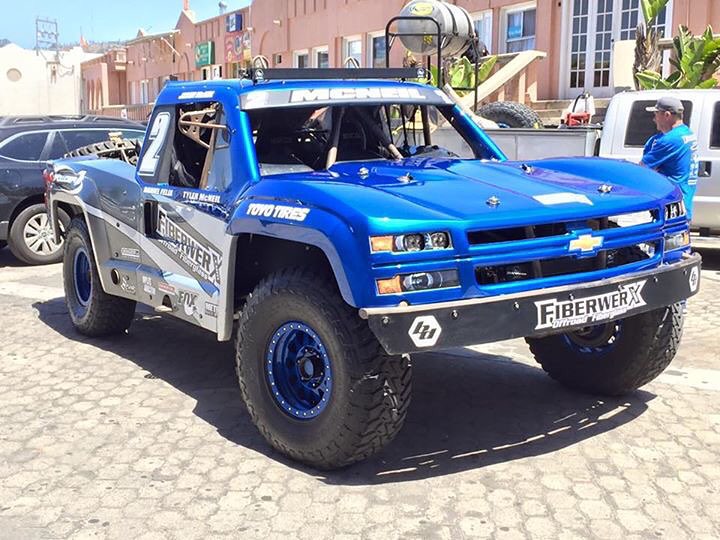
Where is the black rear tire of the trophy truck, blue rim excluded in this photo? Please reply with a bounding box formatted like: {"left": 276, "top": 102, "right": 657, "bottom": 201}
{"left": 63, "top": 217, "right": 135, "bottom": 337}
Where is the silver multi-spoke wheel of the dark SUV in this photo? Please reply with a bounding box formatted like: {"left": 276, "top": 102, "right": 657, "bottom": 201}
{"left": 8, "top": 204, "right": 70, "bottom": 264}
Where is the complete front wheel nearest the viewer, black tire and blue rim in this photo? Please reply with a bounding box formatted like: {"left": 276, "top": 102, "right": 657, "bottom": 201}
{"left": 236, "top": 269, "right": 411, "bottom": 469}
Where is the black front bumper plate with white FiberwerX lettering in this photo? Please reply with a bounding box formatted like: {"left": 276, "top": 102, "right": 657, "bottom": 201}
{"left": 360, "top": 253, "right": 702, "bottom": 354}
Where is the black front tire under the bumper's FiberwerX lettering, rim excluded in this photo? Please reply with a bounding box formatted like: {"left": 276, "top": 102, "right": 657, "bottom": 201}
{"left": 526, "top": 304, "right": 683, "bottom": 396}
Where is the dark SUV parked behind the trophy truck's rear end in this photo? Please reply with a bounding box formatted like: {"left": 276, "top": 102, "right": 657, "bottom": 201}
{"left": 0, "top": 115, "right": 145, "bottom": 264}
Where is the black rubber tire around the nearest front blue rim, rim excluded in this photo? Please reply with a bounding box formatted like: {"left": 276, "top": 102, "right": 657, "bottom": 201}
{"left": 236, "top": 268, "right": 411, "bottom": 469}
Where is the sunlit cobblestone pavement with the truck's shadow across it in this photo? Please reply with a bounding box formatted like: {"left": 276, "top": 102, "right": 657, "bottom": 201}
{"left": 0, "top": 246, "right": 720, "bottom": 540}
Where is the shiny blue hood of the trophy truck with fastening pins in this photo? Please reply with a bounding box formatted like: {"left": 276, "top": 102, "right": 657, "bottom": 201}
{"left": 320, "top": 158, "right": 676, "bottom": 225}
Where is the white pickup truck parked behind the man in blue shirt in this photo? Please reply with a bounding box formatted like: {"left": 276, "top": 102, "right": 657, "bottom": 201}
{"left": 478, "top": 90, "right": 720, "bottom": 246}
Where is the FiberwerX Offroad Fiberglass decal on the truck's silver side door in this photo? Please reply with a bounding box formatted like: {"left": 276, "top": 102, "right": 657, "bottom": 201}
{"left": 157, "top": 208, "right": 222, "bottom": 288}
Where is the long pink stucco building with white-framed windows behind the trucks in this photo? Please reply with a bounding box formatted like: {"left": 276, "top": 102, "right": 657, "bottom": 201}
{"left": 83, "top": 0, "right": 720, "bottom": 116}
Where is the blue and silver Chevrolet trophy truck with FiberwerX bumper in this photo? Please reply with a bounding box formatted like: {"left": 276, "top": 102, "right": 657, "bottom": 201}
{"left": 46, "top": 68, "right": 701, "bottom": 469}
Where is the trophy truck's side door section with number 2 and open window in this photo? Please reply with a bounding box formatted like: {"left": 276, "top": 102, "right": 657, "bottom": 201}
{"left": 137, "top": 102, "right": 232, "bottom": 331}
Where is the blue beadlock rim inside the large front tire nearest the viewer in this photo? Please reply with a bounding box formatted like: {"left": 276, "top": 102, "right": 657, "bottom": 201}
{"left": 265, "top": 321, "right": 332, "bottom": 420}
